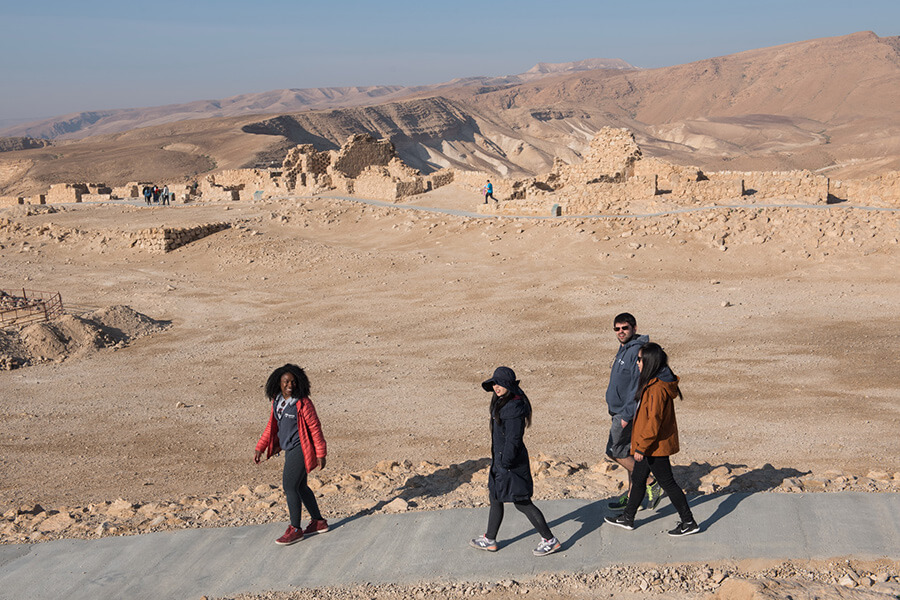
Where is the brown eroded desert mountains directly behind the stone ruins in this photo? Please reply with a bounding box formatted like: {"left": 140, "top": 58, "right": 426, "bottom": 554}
{"left": 0, "top": 32, "right": 900, "bottom": 194}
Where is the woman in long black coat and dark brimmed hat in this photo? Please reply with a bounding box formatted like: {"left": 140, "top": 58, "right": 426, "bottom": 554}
{"left": 469, "top": 367, "right": 561, "bottom": 556}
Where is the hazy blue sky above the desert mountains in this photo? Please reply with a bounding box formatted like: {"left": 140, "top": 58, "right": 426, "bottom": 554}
{"left": 0, "top": 0, "right": 900, "bottom": 122}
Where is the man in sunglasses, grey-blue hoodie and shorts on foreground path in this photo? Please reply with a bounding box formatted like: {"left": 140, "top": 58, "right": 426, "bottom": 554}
{"left": 606, "top": 313, "right": 662, "bottom": 510}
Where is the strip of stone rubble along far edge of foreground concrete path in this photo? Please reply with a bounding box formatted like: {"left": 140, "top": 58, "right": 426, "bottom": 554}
{"left": 0, "top": 454, "right": 900, "bottom": 544}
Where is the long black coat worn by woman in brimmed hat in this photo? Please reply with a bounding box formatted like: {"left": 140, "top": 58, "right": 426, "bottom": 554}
{"left": 488, "top": 392, "right": 534, "bottom": 502}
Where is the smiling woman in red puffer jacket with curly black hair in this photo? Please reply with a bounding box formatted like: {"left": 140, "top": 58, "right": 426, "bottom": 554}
{"left": 253, "top": 364, "right": 328, "bottom": 546}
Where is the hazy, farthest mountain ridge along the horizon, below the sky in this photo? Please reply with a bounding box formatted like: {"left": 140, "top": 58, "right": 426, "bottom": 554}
{"left": 0, "top": 58, "right": 635, "bottom": 140}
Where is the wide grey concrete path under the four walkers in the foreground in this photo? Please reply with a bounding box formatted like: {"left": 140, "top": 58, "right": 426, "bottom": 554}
{"left": 0, "top": 492, "right": 900, "bottom": 600}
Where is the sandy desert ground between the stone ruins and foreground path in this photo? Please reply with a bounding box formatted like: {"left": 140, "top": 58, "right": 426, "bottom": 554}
{"left": 0, "top": 186, "right": 900, "bottom": 597}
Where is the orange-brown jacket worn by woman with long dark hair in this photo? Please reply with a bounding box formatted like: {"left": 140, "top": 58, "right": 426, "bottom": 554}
{"left": 631, "top": 377, "right": 679, "bottom": 456}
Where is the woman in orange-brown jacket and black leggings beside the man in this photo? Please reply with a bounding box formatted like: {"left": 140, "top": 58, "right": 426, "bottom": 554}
{"left": 605, "top": 342, "right": 700, "bottom": 536}
